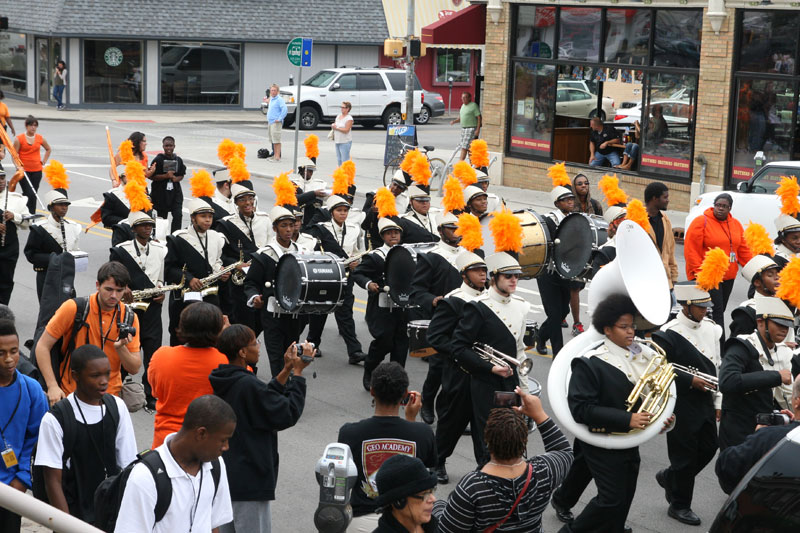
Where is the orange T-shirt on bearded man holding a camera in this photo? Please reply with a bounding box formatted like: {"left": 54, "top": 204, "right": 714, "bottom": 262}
{"left": 45, "top": 292, "right": 140, "bottom": 395}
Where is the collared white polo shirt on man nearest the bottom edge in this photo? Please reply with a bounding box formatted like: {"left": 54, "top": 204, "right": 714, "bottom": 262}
{"left": 114, "top": 433, "right": 233, "bottom": 533}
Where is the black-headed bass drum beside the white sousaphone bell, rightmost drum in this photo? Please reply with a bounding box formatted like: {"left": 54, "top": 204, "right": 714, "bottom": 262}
{"left": 553, "top": 213, "right": 608, "bottom": 280}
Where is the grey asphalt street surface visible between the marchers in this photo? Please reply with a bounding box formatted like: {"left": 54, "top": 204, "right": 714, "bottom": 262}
{"left": 9, "top": 121, "right": 746, "bottom": 533}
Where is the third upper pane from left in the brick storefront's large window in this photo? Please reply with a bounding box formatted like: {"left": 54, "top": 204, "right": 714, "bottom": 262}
{"left": 605, "top": 9, "right": 651, "bottom": 65}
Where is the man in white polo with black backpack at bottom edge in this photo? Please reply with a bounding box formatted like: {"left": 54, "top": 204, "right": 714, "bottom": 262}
{"left": 114, "top": 394, "right": 236, "bottom": 533}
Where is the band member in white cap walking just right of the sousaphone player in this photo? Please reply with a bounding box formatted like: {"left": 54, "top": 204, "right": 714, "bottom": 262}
{"left": 653, "top": 280, "right": 724, "bottom": 526}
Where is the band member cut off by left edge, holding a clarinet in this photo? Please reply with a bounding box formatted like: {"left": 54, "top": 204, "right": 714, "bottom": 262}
{"left": 0, "top": 169, "right": 31, "bottom": 305}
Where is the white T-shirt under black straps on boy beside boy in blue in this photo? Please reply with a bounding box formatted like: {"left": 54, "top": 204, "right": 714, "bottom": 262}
{"left": 34, "top": 392, "right": 136, "bottom": 470}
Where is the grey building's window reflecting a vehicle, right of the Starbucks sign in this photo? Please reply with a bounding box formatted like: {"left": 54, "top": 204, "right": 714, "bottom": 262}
{"left": 161, "top": 42, "right": 241, "bottom": 105}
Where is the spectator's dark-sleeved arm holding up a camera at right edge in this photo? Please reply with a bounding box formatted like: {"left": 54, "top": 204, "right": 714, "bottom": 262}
{"left": 715, "top": 380, "right": 800, "bottom": 494}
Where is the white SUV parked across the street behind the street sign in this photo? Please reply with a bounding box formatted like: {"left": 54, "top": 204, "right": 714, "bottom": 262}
{"left": 280, "top": 67, "right": 423, "bottom": 130}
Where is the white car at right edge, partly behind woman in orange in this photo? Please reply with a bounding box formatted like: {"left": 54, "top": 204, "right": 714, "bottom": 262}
{"left": 684, "top": 161, "right": 800, "bottom": 237}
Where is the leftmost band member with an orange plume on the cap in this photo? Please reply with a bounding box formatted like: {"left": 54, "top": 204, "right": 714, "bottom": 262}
{"left": 25, "top": 172, "right": 81, "bottom": 301}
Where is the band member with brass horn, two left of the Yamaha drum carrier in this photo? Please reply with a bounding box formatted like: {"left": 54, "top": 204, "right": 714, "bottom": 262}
{"left": 165, "top": 176, "right": 230, "bottom": 346}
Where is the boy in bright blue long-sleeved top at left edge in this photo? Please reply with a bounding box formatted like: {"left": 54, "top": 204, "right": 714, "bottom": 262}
{"left": 0, "top": 318, "right": 47, "bottom": 533}
